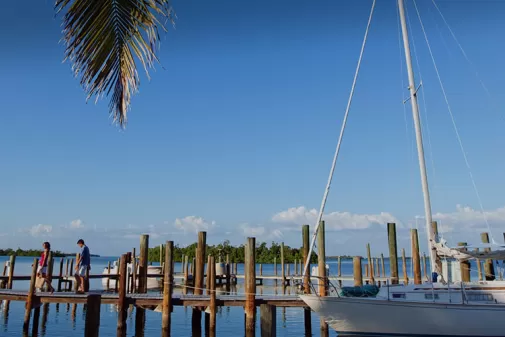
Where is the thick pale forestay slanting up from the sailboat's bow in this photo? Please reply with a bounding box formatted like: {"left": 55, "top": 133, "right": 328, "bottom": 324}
{"left": 303, "top": 0, "right": 376, "bottom": 276}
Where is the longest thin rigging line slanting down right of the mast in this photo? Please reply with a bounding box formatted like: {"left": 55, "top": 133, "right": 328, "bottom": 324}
{"left": 413, "top": 0, "right": 496, "bottom": 244}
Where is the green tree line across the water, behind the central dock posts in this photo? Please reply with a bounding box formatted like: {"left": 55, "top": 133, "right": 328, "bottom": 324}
{"left": 148, "top": 240, "right": 317, "bottom": 263}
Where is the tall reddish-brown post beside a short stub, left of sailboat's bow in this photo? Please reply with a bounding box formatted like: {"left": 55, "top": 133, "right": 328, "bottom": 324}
{"left": 244, "top": 238, "right": 256, "bottom": 333}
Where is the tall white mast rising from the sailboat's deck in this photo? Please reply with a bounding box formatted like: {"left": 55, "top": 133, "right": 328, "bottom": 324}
{"left": 398, "top": 0, "right": 441, "bottom": 274}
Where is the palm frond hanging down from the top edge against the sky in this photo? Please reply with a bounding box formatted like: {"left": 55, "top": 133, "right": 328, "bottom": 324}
{"left": 55, "top": 0, "right": 175, "bottom": 126}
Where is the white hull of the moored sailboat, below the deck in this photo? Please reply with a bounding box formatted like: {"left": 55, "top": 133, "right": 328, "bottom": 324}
{"left": 300, "top": 295, "right": 505, "bottom": 337}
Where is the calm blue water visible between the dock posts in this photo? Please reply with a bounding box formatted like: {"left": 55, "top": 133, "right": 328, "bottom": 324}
{"left": 0, "top": 256, "right": 484, "bottom": 337}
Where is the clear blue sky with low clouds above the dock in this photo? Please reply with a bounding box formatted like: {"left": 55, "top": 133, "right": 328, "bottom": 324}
{"left": 0, "top": 0, "right": 505, "bottom": 254}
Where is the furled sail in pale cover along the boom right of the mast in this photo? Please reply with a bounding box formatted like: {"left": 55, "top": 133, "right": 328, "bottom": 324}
{"left": 433, "top": 239, "right": 505, "bottom": 261}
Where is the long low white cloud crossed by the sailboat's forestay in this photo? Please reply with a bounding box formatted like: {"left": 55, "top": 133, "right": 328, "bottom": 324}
{"left": 272, "top": 206, "right": 401, "bottom": 230}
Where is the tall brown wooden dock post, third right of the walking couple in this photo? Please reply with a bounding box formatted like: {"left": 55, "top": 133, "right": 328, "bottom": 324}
{"left": 161, "top": 241, "right": 174, "bottom": 337}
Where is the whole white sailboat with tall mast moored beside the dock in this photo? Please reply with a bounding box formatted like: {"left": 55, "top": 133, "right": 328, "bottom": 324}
{"left": 300, "top": 0, "right": 505, "bottom": 336}
